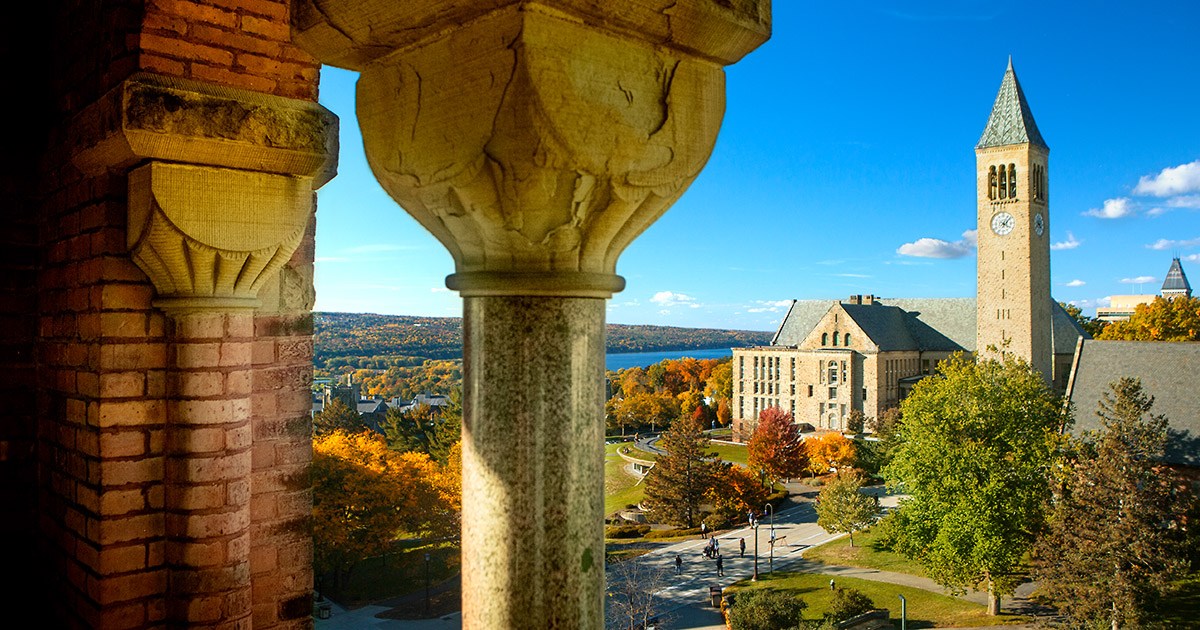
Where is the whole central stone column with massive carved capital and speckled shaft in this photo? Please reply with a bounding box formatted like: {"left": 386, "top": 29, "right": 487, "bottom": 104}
{"left": 293, "top": 0, "right": 769, "bottom": 629}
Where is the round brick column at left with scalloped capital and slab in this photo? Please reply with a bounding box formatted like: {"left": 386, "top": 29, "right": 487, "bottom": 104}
{"left": 77, "top": 74, "right": 336, "bottom": 628}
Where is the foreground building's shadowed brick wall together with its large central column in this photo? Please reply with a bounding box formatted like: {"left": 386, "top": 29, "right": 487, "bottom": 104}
{"left": 0, "top": 0, "right": 770, "bottom": 629}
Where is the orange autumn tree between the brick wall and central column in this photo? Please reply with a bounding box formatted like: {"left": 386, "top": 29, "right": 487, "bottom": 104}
{"left": 312, "top": 431, "right": 462, "bottom": 588}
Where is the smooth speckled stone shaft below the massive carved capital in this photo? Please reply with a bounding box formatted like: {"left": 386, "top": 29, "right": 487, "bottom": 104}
{"left": 462, "top": 296, "right": 605, "bottom": 629}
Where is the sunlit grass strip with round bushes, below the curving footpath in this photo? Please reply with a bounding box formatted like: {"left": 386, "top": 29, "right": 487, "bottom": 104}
{"left": 730, "top": 572, "right": 1030, "bottom": 628}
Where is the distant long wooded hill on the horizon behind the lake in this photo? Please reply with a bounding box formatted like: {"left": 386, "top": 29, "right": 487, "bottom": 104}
{"left": 313, "top": 313, "right": 772, "bottom": 366}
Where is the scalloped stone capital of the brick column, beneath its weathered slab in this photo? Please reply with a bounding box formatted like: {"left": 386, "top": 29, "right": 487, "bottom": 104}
{"left": 128, "top": 162, "right": 313, "bottom": 311}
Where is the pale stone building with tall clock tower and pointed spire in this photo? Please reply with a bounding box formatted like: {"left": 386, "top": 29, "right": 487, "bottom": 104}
{"left": 733, "top": 60, "right": 1087, "bottom": 438}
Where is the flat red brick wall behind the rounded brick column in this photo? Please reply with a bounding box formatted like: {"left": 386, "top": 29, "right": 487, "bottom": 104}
{"left": 27, "top": 0, "right": 318, "bottom": 628}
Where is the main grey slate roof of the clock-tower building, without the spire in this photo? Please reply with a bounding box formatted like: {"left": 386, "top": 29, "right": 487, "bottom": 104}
{"left": 770, "top": 298, "right": 1087, "bottom": 354}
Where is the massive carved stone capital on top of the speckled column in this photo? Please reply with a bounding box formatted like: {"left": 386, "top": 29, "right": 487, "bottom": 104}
{"left": 294, "top": 0, "right": 769, "bottom": 298}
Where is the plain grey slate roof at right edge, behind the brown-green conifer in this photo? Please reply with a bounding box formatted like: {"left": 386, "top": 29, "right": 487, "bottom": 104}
{"left": 1067, "top": 340, "right": 1200, "bottom": 466}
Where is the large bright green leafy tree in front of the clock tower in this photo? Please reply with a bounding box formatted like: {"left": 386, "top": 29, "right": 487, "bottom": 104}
{"left": 883, "top": 354, "right": 1063, "bottom": 614}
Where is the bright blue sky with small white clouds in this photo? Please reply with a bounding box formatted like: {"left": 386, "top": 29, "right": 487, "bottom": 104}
{"left": 317, "top": 0, "right": 1200, "bottom": 330}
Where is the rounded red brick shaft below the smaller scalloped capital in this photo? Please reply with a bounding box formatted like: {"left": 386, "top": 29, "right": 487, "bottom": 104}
{"left": 164, "top": 308, "right": 254, "bottom": 628}
